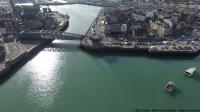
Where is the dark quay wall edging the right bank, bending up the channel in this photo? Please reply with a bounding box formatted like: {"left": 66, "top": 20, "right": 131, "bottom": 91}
{"left": 80, "top": 4, "right": 200, "bottom": 56}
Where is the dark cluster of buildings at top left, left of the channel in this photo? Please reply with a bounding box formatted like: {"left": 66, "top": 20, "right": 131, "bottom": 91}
{"left": 0, "top": 0, "right": 55, "bottom": 37}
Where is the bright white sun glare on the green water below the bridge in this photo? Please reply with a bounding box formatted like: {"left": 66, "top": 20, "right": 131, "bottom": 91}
{"left": 27, "top": 52, "right": 62, "bottom": 109}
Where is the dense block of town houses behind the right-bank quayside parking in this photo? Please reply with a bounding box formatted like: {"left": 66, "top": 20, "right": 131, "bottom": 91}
{"left": 102, "top": 0, "right": 197, "bottom": 37}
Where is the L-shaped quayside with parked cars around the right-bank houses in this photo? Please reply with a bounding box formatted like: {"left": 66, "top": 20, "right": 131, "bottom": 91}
{"left": 81, "top": 4, "right": 200, "bottom": 55}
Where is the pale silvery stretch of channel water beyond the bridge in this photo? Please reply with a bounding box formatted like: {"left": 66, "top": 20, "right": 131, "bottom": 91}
{"left": 50, "top": 4, "right": 101, "bottom": 35}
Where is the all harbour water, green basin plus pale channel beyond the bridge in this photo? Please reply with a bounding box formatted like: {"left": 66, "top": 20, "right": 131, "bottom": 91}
{"left": 0, "top": 5, "right": 200, "bottom": 112}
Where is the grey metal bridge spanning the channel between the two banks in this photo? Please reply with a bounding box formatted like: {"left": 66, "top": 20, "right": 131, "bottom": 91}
{"left": 19, "top": 30, "right": 84, "bottom": 40}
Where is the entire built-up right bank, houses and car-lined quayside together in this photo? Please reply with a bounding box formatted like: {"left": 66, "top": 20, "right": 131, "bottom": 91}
{"left": 81, "top": 2, "right": 200, "bottom": 55}
